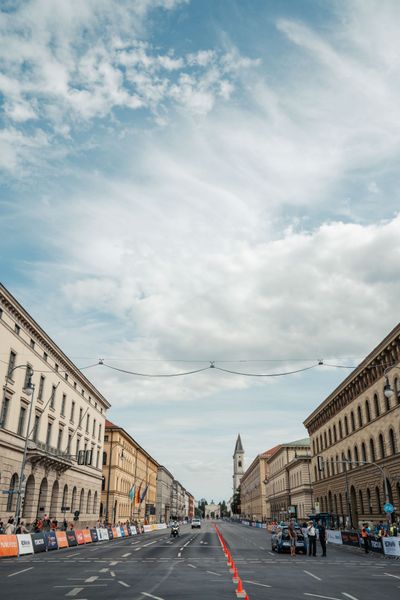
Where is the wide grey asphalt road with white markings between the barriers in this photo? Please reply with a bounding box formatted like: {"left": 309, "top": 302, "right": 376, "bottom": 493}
{"left": 0, "top": 523, "right": 400, "bottom": 600}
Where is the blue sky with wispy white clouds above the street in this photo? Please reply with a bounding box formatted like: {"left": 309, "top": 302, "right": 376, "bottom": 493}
{"left": 0, "top": 0, "right": 400, "bottom": 500}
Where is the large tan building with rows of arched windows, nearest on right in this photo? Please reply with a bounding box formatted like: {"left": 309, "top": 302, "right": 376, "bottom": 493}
{"left": 304, "top": 324, "right": 400, "bottom": 526}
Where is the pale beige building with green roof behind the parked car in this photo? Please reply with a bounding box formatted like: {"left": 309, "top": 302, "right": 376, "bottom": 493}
{"left": 266, "top": 438, "right": 313, "bottom": 521}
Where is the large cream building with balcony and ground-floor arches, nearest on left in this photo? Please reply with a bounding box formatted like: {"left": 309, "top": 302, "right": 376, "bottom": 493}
{"left": 0, "top": 285, "right": 110, "bottom": 525}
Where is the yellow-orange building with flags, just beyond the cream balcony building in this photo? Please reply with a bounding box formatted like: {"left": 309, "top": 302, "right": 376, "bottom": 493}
{"left": 100, "top": 421, "right": 159, "bottom": 524}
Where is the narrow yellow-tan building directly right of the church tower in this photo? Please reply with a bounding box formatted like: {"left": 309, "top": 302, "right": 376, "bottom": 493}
{"left": 240, "top": 446, "right": 279, "bottom": 521}
